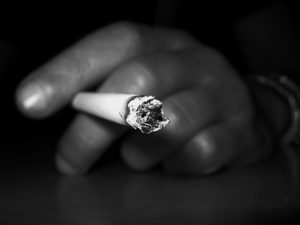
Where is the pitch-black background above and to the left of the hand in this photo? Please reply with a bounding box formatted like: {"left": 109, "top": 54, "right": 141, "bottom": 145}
{"left": 0, "top": 0, "right": 299, "bottom": 144}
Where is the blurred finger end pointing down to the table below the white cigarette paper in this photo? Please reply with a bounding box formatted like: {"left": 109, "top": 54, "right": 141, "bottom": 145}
{"left": 55, "top": 114, "right": 125, "bottom": 175}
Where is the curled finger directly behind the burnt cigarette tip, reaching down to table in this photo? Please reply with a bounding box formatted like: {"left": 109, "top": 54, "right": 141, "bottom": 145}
{"left": 121, "top": 87, "right": 220, "bottom": 170}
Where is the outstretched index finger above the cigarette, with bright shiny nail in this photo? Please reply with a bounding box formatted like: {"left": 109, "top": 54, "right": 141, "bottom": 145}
{"left": 16, "top": 23, "right": 197, "bottom": 118}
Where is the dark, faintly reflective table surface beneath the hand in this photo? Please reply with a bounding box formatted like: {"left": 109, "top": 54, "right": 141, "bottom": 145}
{"left": 0, "top": 140, "right": 300, "bottom": 225}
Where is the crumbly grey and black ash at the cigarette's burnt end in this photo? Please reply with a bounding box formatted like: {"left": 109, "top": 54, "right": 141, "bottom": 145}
{"left": 126, "top": 96, "right": 170, "bottom": 134}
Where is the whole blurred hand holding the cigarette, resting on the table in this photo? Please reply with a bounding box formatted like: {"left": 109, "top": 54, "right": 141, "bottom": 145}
{"left": 17, "top": 23, "right": 271, "bottom": 174}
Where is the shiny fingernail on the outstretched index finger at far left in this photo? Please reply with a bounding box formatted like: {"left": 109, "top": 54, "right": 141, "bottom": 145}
{"left": 18, "top": 84, "right": 47, "bottom": 111}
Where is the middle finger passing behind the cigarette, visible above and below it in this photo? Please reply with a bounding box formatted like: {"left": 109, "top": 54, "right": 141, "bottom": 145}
{"left": 56, "top": 51, "right": 205, "bottom": 174}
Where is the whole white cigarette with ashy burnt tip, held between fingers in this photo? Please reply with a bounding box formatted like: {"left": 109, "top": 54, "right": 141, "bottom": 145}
{"left": 72, "top": 92, "right": 170, "bottom": 134}
